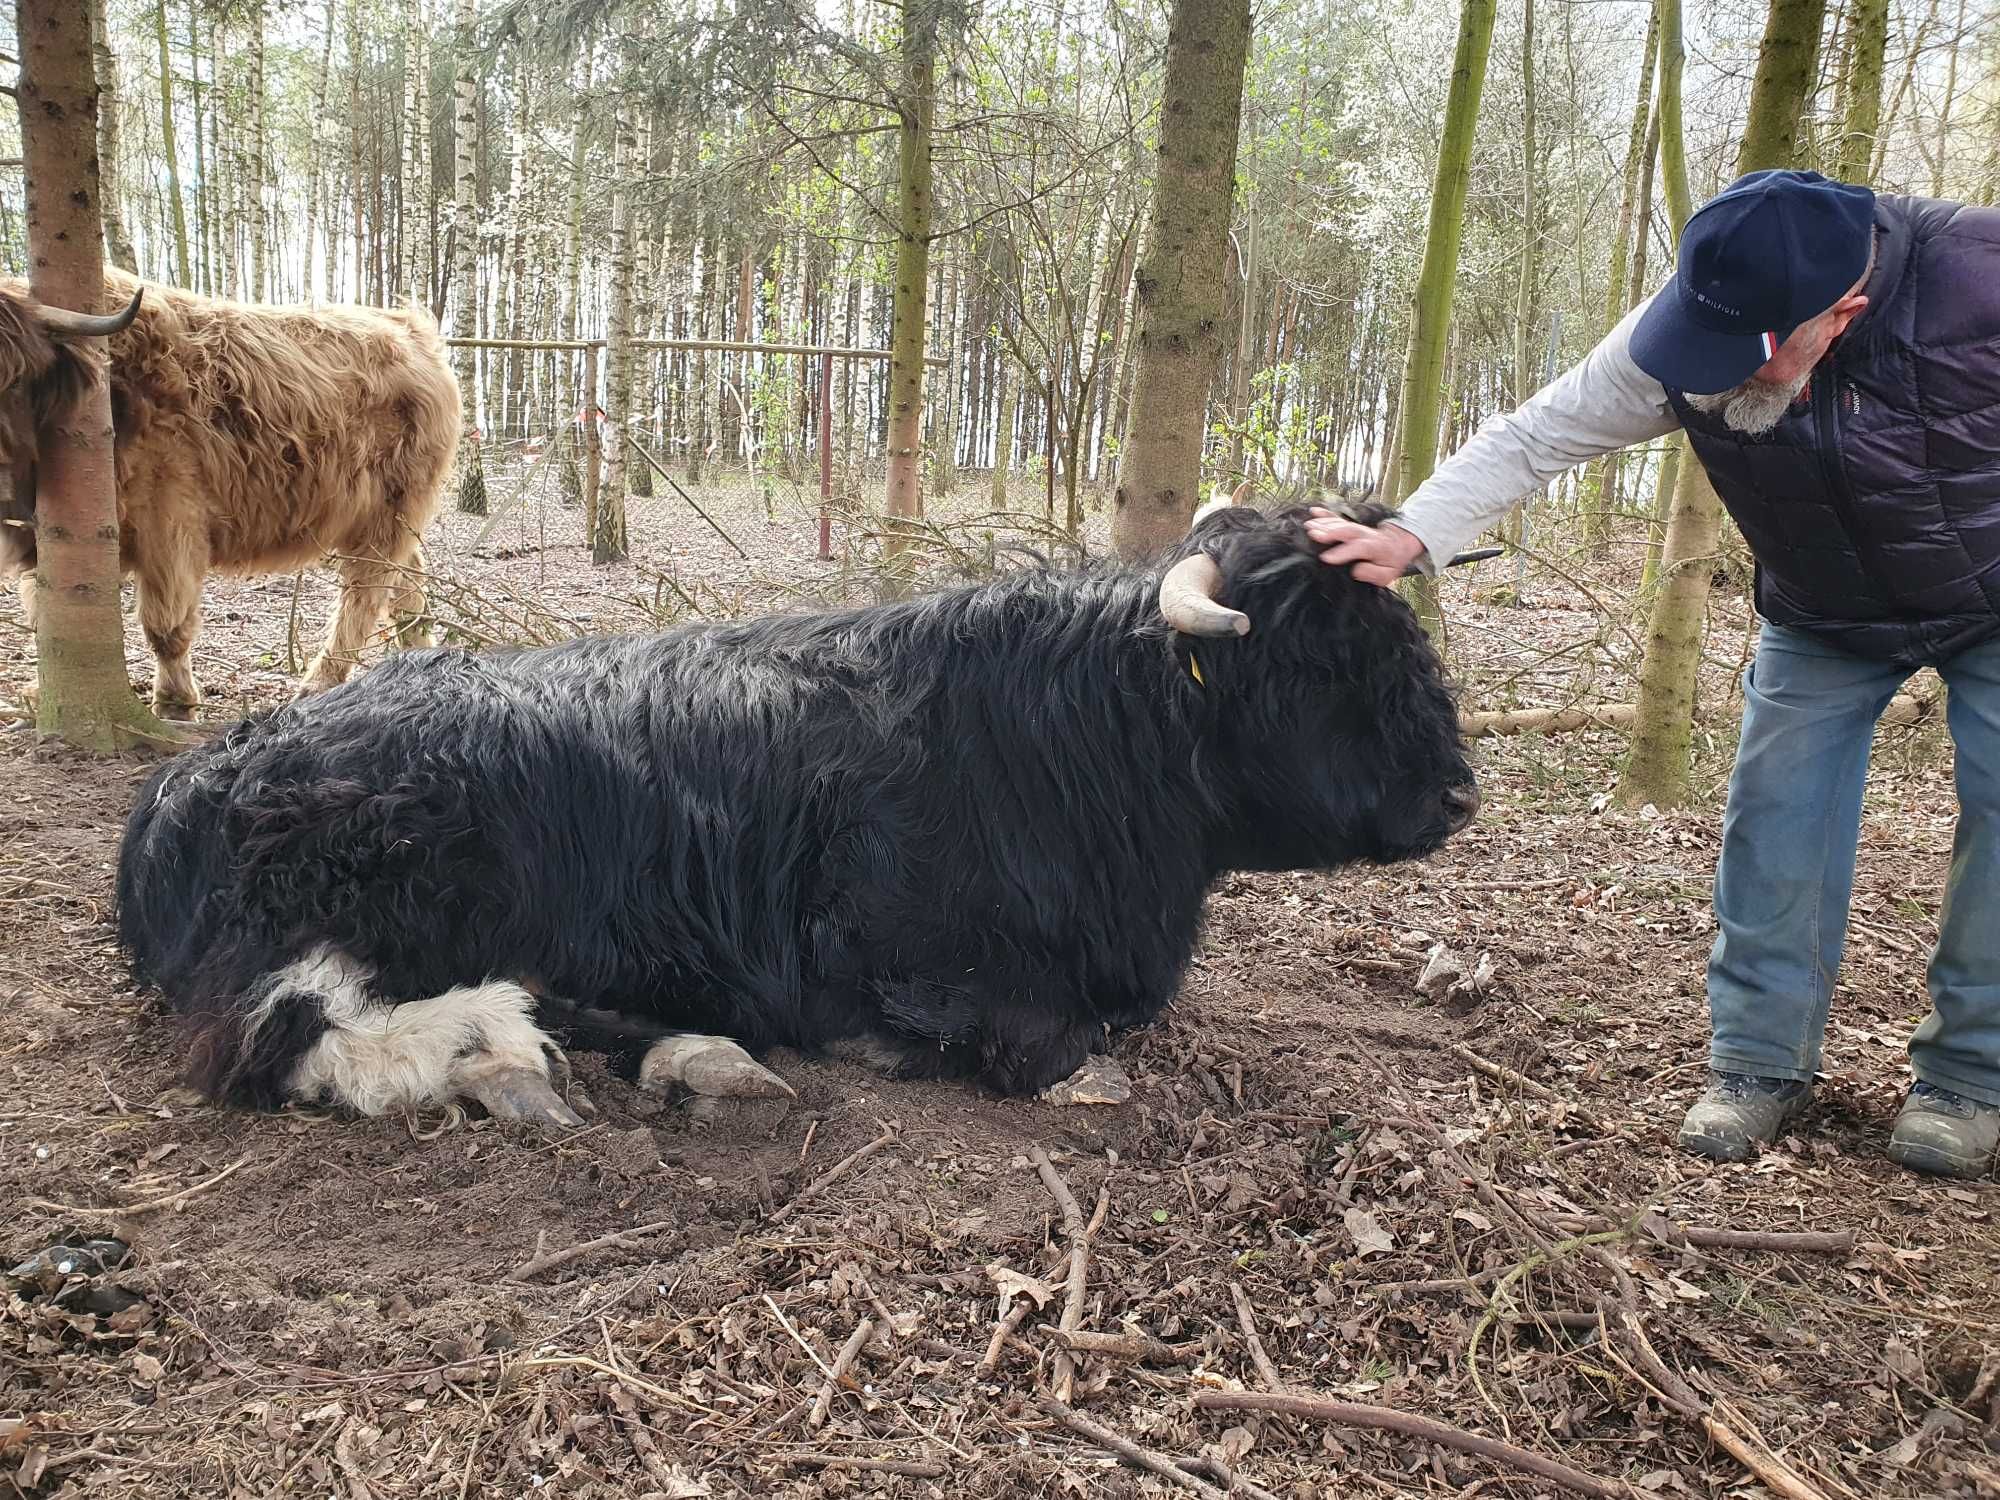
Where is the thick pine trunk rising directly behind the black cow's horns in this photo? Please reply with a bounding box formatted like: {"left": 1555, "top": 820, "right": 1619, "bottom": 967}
{"left": 1112, "top": 0, "right": 1250, "bottom": 560}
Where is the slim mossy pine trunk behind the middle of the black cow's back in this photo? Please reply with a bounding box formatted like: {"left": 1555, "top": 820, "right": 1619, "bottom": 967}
{"left": 884, "top": 4, "right": 938, "bottom": 594}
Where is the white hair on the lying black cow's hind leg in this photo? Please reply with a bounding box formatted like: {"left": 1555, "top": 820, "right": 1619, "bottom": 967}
{"left": 264, "top": 950, "right": 550, "bottom": 1114}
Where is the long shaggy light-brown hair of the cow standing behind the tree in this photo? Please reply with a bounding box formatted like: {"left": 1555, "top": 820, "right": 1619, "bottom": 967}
{"left": 0, "top": 268, "right": 460, "bottom": 704}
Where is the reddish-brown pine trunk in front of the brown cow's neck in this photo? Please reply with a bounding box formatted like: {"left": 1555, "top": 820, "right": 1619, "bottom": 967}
{"left": 14, "top": 0, "right": 168, "bottom": 752}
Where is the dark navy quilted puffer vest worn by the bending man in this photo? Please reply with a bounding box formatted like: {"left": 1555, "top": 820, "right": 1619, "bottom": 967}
{"left": 1668, "top": 196, "right": 2000, "bottom": 666}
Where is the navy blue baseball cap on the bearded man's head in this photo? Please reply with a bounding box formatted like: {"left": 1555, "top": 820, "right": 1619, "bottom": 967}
{"left": 1632, "top": 172, "right": 1874, "bottom": 396}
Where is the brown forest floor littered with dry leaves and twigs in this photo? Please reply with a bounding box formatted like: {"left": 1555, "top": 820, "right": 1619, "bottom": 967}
{"left": 0, "top": 478, "right": 2000, "bottom": 1500}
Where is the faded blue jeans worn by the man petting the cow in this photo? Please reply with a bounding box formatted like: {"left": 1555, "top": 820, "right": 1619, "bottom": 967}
{"left": 1708, "top": 624, "right": 2000, "bottom": 1104}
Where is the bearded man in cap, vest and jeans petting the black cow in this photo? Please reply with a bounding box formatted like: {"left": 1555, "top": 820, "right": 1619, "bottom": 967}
{"left": 1308, "top": 172, "right": 2000, "bottom": 1176}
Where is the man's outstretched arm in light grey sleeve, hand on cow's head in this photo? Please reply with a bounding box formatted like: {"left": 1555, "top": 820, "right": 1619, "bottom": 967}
{"left": 1306, "top": 302, "right": 1680, "bottom": 584}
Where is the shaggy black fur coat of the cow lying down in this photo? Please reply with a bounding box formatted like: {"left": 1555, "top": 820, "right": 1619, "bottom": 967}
{"left": 118, "top": 508, "right": 1472, "bottom": 1104}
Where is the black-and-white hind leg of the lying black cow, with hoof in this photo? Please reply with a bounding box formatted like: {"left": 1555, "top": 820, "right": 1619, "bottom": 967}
{"left": 229, "top": 952, "right": 582, "bottom": 1126}
